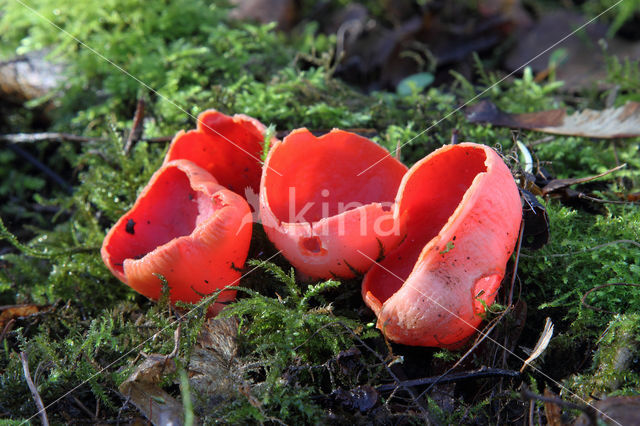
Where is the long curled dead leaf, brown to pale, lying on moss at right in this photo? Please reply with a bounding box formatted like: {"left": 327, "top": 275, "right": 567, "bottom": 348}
{"left": 465, "top": 100, "right": 640, "bottom": 139}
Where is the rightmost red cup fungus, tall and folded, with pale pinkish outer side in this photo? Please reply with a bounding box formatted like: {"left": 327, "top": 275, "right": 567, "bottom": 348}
{"left": 362, "top": 143, "right": 522, "bottom": 347}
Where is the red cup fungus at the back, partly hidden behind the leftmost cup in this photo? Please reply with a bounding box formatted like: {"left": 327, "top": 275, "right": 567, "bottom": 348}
{"left": 164, "top": 109, "right": 266, "bottom": 196}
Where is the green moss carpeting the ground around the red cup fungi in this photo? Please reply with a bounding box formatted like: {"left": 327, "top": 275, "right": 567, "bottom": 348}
{"left": 0, "top": 0, "right": 640, "bottom": 423}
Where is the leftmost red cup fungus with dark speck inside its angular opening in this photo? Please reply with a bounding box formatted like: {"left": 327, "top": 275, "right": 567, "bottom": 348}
{"left": 101, "top": 160, "right": 251, "bottom": 303}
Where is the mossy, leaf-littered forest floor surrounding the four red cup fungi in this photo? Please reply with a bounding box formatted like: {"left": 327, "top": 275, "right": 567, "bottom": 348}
{"left": 0, "top": 0, "right": 640, "bottom": 425}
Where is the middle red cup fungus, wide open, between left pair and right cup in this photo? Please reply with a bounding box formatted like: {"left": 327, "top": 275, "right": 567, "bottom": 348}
{"left": 260, "top": 129, "right": 407, "bottom": 278}
